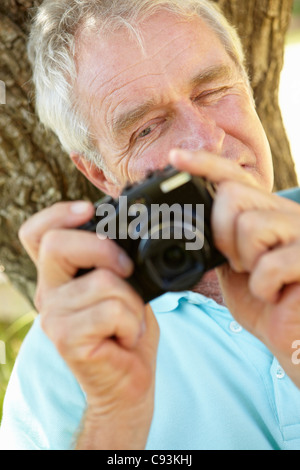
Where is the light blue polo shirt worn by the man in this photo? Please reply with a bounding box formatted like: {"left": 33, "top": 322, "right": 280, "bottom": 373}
{"left": 0, "top": 187, "right": 300, "bottom": 450}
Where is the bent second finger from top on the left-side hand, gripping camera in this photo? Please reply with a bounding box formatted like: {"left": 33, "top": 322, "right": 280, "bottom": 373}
{"left": 38, "top": 230, "right": 133, "bottom": 288}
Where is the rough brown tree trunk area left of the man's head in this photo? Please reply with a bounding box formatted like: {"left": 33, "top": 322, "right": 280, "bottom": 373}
{"left": 0, "top": 0, "right": 100, "bottom": 300}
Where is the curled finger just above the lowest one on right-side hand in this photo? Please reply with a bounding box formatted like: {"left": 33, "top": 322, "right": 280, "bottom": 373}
{"left": 235, "top": 210, "right": 300, "bottom": 272}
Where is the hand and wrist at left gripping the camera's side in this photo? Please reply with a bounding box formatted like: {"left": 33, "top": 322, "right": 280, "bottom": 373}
{"left": 19, "top": 202, "right": 159, "bottom": 449}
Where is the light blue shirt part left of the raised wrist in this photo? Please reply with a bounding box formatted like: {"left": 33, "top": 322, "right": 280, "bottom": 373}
{"left": 0, "top": 317, "right": 86, "bottom": 450}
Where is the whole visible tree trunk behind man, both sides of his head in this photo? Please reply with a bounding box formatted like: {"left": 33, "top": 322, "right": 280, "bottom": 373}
{"left": 0, "top": 0, "right": 297, "bottom": 299}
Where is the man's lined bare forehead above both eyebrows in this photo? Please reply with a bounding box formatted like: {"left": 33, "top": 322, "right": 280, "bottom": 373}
{"left": 76, "top": 11, "right": 232, "bottom": 123}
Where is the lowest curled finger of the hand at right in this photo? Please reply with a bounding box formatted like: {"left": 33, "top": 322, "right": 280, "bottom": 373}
{"left": 249, "top": 242, "right": 300, "bottom": 303}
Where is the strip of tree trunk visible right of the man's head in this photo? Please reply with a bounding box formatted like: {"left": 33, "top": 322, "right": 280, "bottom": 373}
{"left": 215, "top": 0, "right": 298, "bottom": 190}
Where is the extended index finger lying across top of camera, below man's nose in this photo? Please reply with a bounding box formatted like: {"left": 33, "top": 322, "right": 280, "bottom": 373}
{"left": 169, "top": 149, "right": 258, "bottom": 187}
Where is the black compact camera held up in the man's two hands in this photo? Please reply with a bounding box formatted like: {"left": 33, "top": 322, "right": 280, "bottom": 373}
{"left": 78, "top": 166, "right": 226, "bottom": 303}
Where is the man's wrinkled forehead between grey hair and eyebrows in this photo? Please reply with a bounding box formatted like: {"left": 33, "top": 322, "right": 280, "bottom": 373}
{"left": 72, "top": 11, "right": 231, "bottom": 107}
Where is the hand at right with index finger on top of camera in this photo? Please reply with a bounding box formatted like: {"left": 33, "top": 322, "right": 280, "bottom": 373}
{"left": 170, "top": 150, "right": 300, "bottom": 387}
